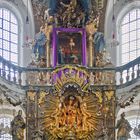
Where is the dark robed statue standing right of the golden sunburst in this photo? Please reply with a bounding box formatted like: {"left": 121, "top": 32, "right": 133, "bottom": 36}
{"left": 116, "top": 112, "right": 132, "bottom": 140}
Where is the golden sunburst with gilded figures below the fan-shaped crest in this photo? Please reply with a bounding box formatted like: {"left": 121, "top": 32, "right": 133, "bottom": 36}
{"left": 42, "top": 92, "right": 101, "bottom": 140}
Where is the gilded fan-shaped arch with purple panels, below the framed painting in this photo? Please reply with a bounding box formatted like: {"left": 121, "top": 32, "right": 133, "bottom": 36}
{"left": 53, "top": 65, "right": 89, "bottom": 92}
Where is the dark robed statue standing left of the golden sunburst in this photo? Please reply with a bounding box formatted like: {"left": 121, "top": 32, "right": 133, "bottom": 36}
{"left": 11, "top": 110, "right": 25, "bottom": 140}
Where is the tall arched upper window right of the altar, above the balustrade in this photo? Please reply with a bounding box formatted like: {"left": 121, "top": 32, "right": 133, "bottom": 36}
{"left": 119, "top": 9, "right": 140, "bottom": 65}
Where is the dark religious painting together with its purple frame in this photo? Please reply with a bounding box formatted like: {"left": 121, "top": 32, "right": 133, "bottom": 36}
{"left": 53, "top": 28, "right": 86, "bottom": 66}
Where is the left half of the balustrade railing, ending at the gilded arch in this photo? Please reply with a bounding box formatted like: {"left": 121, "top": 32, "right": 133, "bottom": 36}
{"left": 0, "top": 56, "right": 53, "bottom": 87}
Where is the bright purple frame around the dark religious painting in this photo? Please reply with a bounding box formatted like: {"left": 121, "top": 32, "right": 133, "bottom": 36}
{"left": 52, "top": 28, "right": 87, "bottom": 67}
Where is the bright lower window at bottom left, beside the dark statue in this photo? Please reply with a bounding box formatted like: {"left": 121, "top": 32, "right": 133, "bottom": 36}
{"left": 0, "top": 117, "right": 12, "bottom": 140}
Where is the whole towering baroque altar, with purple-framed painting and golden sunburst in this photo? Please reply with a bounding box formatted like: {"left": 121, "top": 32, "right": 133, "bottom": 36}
{"left": 26, "top": 0, "right": 116, "bottom": 140}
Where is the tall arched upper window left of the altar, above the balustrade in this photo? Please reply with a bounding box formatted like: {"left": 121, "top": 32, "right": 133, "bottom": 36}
{"left": 0, "top": 8, "right": 18, "bottom": 65}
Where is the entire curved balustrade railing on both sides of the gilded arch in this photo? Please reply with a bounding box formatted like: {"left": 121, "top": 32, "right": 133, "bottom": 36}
{"left": 0, "top": 56, "right": 140, "bottom": 88}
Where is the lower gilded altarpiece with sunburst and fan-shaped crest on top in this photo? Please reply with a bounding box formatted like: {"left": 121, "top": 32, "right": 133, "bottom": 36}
{"left": 27, "top": 65, "right": 115, "bottom": 140}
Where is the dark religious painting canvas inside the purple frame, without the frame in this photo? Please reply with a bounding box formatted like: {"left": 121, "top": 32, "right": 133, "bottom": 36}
{"left": 57, "top": 32, "right": 82, "bottom": 64}
